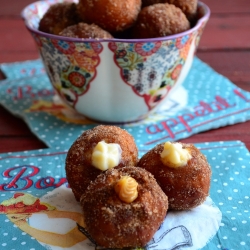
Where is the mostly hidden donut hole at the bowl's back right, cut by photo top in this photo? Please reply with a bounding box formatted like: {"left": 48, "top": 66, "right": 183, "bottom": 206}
{"left": 142, "top": 0, "right": 198, "bottom": 20}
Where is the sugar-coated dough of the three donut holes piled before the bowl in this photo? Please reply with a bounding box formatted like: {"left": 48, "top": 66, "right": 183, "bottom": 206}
{"left": 65, "top": 125, "right": 211, "bottom": 248}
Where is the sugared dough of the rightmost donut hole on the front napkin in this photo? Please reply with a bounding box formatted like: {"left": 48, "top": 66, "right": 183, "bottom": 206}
{"left": 138, "top": 143, "right": 211, "bottom": 210}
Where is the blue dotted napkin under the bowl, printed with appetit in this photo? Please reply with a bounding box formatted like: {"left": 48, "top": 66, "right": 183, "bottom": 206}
{"left": 0, "top": 58, "right": 250, "bottom": 155}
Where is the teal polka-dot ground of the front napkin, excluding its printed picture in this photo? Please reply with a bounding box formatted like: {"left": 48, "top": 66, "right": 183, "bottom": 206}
{"left": 0, "top": 141, "right": 250, "bottom": 250}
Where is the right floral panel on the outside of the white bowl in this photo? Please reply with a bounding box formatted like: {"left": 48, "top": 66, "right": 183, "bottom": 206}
{"left": 109, "top": 34, "right": 194, "bottom": 110}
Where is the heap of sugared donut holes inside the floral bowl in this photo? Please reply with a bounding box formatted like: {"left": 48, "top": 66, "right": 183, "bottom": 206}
{"left": 38, "top": 0, "right": 198, "bottom": 39}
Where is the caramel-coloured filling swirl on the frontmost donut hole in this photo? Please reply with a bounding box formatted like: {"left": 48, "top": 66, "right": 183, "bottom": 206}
{"left": 115, "top": 176, "right": 138, "bottom": 203}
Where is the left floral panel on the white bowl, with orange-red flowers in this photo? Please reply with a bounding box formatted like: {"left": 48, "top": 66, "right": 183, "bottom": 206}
{"left": 35, "top": 35, "right": 103, "bottom": 106}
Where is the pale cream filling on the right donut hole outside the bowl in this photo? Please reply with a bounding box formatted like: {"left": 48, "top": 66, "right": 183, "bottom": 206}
{"left": 161, "top": 142, "right": 192, "bottom": 168}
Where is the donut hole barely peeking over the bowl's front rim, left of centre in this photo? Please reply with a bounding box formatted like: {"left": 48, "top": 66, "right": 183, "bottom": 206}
{"left": 59, "top": 23, "right": 113, "bottom": 39}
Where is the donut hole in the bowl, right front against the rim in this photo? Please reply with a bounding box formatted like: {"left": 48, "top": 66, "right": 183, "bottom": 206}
{"left": 133, "top": 3, "right": 190, "bottom": 38}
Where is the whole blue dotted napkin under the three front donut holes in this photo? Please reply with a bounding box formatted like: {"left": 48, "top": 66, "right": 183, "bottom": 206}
{"left": 0, "top": 141, "right": 250, "bottom": 250}
